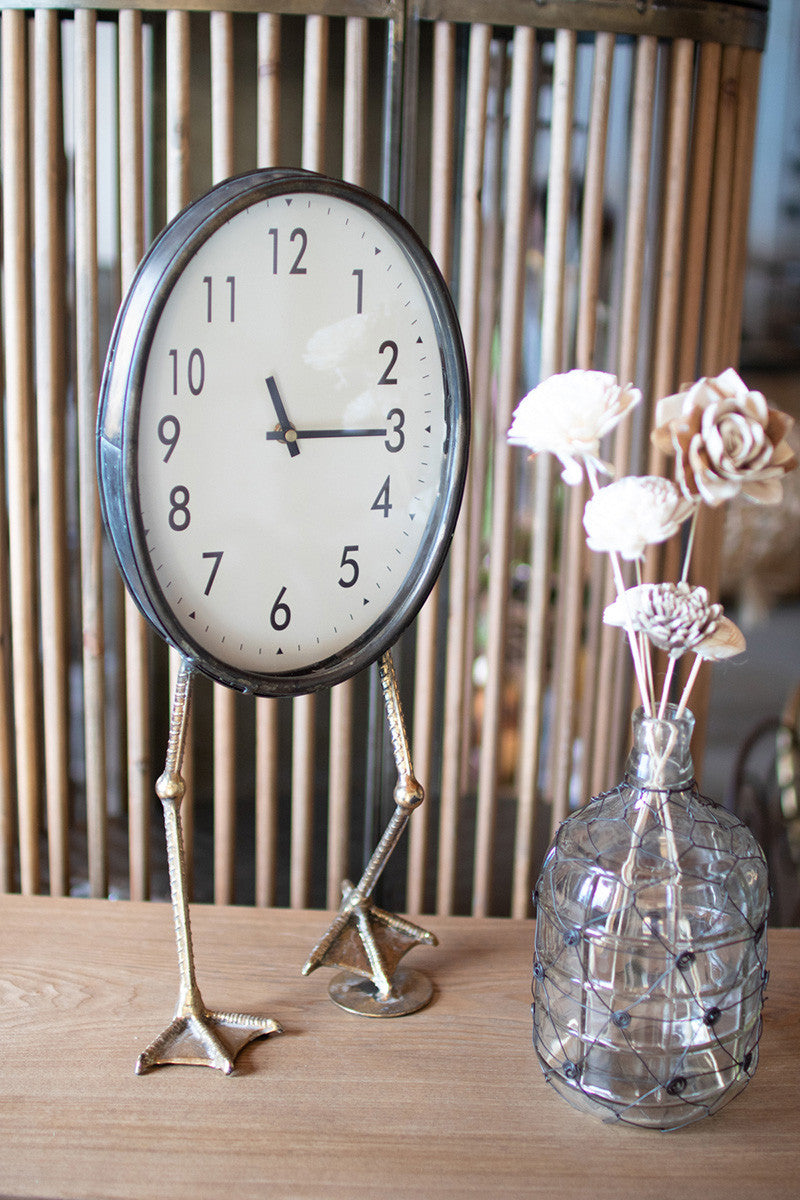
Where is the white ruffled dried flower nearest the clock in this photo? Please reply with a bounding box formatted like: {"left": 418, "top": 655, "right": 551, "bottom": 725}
{"left": 509, "top": 370, "right": 642, "bottom": 485}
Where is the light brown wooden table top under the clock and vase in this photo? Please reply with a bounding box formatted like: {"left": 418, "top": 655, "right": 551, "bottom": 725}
{"left": 0, "top": 895, "right": 800, "bottom": 1200}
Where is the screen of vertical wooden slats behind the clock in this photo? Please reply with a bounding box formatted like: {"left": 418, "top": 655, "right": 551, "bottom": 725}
{"left": 0, "top": 0, "right": 765, "bottom": 916}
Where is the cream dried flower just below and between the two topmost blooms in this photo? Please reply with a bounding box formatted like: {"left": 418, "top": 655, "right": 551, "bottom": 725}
{"left": 583, "top": 475, "right": 694, "bottom": 559}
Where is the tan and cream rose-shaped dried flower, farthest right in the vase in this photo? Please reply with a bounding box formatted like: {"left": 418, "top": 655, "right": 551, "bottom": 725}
{"left": 651, "top": 367, "right": 796, "bottom": 506}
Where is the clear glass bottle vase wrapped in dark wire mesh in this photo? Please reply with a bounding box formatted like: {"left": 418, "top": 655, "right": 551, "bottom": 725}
{"left": 533, "top": 706, "right": 769, "bottom": 1129}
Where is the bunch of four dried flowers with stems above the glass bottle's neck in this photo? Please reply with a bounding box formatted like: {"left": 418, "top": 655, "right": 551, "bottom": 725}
{"left": 509, "top": 368, "right": 796, "bottom": 716}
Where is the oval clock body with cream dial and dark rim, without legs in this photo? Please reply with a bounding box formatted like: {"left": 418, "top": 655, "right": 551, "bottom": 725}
{"left": 100, "top": 172, "right": 467, "bottom": 694}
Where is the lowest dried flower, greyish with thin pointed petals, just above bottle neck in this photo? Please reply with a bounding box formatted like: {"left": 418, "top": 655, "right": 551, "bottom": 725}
{"left": 603, "top": 583, "right": 745, "bottom": 659}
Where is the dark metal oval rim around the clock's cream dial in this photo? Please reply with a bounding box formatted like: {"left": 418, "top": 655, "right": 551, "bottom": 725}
{"left": 97, "top": 168, "right": 469, "bottom": 696}
